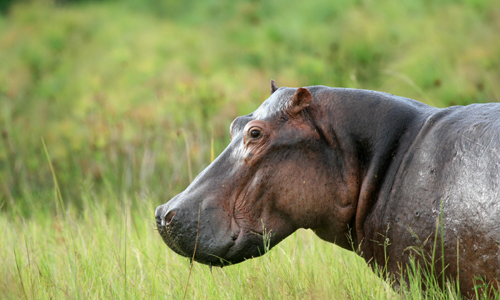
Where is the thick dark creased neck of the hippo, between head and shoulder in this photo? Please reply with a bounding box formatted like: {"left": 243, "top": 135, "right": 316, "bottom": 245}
{"left": 310, "top": 87, "right": 437, "bottom": 250}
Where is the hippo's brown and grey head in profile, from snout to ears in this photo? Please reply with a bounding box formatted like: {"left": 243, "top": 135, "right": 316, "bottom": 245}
{"left": 156, "top": 81, "right": 355, "bottom": 266}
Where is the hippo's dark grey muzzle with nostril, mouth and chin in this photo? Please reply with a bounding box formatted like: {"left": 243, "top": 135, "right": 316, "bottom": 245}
{"left": 155, "top": 191, "right": 280, "bottom": 267}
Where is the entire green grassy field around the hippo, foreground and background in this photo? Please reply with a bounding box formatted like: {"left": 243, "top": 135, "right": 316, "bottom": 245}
{"left": 0, "top": 0, "right": 500, "bottom": 299}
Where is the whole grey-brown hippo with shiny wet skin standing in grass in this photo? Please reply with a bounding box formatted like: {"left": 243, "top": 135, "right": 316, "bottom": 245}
{"left": 156, "top": 81, "right": 500, "bottom": 295}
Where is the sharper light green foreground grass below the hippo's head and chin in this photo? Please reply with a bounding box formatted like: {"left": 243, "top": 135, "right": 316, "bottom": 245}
{"left": 0, "top": 191, "right": 397, "bottom": 299}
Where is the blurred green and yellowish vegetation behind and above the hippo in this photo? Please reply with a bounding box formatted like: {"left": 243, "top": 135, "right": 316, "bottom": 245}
{"left": 0, "top": 0, "right": 500, "bottom": 217}
